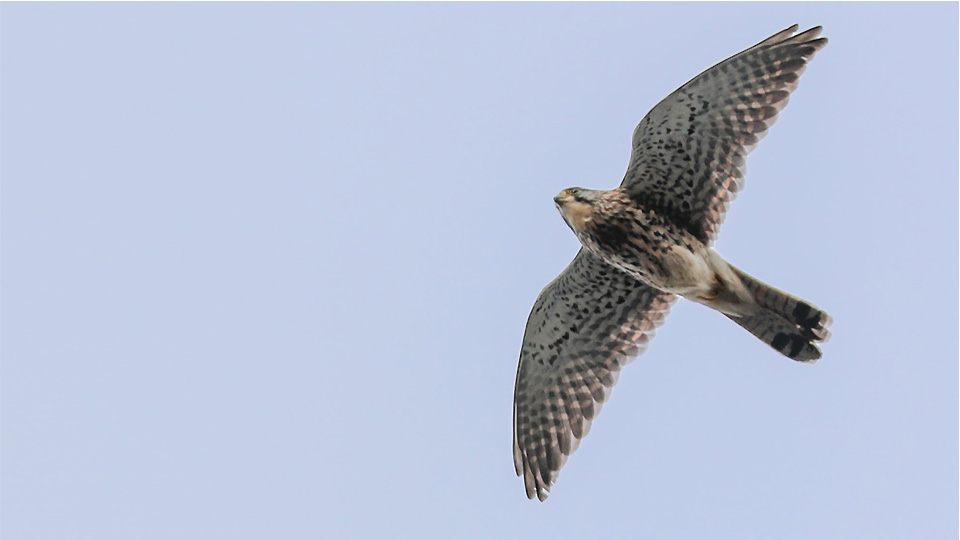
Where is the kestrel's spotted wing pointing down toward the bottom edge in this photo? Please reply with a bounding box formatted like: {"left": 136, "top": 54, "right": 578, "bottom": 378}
{"left": 513, "top": 249, "right": 674, "bottom": 501}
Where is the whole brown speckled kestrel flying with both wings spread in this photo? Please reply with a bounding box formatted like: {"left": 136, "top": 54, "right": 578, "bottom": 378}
{"left": 513, "top": 25, "right": 831, "bottom": 501}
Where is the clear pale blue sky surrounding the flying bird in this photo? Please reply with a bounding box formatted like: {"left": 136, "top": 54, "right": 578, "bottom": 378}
{"left": 0, "top": 3, "right": 958, "bottom": 540}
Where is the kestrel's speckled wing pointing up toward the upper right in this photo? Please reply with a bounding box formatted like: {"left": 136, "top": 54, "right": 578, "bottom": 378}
{"left": 621, "top": 25, "right": 827, "bottom": 243}
